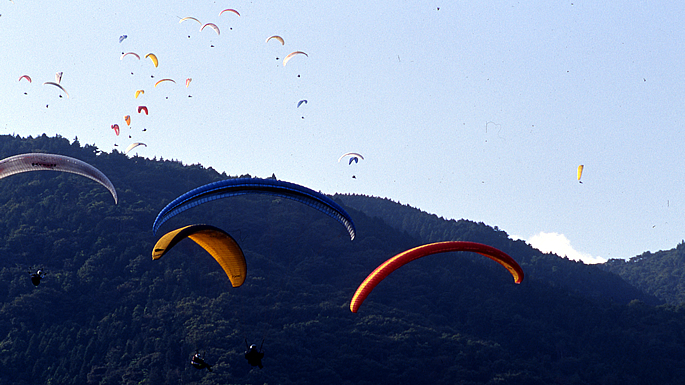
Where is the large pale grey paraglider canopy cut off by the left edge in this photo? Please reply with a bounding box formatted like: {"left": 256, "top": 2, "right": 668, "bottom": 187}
{"left": 0, "top": 153, "right": 118, "bottom": 204}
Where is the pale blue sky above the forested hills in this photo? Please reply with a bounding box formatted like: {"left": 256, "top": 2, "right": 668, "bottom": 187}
{"left": 0, "top": 0, "right": 685, "bottom": 263}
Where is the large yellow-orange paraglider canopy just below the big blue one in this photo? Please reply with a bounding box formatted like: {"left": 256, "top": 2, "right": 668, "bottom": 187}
{"left": 152, "top": 225, "right": 247, "bottom": 287}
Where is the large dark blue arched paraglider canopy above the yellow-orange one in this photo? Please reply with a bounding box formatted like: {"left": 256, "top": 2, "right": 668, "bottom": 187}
{"left": 152, "top": 178, "right": 355, "bottom": 239}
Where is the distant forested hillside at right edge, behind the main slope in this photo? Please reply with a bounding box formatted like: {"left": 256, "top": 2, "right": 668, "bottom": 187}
{"left": 601, "top": 242, "right": 685, "bottom": 305}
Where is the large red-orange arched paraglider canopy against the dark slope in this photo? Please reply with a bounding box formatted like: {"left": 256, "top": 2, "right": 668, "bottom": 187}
{"left": 350, "top": 241, "right": 523, "bottom": 313}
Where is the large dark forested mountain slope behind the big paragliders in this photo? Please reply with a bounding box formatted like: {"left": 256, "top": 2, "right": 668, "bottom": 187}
{"left": 0, "top": 136, "right": 685, "bottom": 385}
